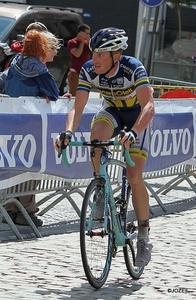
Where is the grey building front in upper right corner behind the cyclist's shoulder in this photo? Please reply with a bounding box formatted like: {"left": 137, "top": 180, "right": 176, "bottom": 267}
{"left": 136, "top": 1, "right": 196, "bottom": 82}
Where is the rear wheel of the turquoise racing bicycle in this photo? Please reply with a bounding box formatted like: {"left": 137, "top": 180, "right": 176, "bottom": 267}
{"left": 123, "top": 186, "right": 144, "bottom": 279}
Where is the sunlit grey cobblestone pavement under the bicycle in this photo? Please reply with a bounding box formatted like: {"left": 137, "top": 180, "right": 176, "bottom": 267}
{"left": 0, "top": 177, "right": 196, "bottom": 300}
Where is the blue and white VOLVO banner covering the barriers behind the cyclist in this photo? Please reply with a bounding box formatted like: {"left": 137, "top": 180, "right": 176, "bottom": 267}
{"left": 0, "top": 97, "right": 196, "bottom": 189}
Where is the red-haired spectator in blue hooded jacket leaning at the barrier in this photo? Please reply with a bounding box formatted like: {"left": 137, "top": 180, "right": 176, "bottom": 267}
{"left": 5, "top": 30, "right": 59, "bottom": 101}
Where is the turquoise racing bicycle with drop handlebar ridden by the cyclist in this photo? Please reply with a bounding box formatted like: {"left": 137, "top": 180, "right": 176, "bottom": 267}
{"left": 62, "top": 140, "right": 144, "bottom": 289}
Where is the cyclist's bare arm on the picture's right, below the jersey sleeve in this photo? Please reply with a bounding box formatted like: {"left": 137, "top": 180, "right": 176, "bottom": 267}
{"left": 131, "top": 86, "right": 155, "bottom": 135}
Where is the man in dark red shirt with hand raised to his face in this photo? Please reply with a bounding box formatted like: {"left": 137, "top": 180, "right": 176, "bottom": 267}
{"left": 67, "top": 24, "right": 90, "bottom": 96}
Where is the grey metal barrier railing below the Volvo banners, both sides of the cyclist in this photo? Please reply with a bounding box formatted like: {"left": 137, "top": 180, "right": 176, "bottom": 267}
{"left": 0, "top": 147, "right": 196, "bottom": 240}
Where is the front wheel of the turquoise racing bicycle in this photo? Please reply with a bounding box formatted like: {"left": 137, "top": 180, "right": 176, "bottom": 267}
{"left": 80, "top": 178, "right": 114, "bottom": 289}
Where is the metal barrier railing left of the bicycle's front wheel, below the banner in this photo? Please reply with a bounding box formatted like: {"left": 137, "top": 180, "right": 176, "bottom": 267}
{"left": 0, "top": 176, "right": 90, "bottom": 240}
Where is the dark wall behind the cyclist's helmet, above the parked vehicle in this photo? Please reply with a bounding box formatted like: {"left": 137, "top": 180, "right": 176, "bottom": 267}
{"left": 26, "top": 0, "right": 139, "bottom": 55}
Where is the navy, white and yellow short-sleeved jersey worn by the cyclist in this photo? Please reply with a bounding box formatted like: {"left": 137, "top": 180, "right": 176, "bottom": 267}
{"left": 77, "top": 55, "right": 150, "bottom": 109}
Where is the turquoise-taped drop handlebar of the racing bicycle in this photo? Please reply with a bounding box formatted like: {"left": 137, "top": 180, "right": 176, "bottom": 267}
{"left": 62, "top": 140, "right": 135, "bottom": 168}
